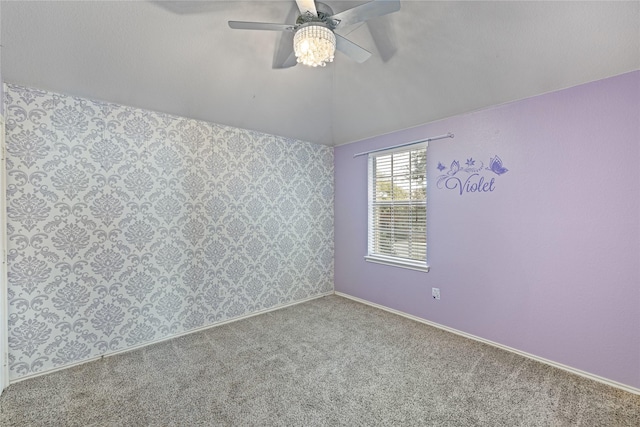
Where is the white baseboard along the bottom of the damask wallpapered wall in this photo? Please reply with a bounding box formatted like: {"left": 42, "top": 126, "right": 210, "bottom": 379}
{"left": 9, "top": 291, "right": 333, "bottom": 384}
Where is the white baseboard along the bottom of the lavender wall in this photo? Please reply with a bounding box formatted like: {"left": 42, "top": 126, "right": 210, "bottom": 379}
{"left": 335, "top": 292, "right": 640, "bottom": 395}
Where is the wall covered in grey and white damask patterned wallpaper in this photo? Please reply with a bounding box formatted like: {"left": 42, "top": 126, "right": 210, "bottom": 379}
{"left": 5, "top": 85, "right": 333, "bottom": 379}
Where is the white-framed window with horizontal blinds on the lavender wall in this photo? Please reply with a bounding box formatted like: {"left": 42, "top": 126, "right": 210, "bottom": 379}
{"left": 365, "top": 143, "right": 429, "bottom": 271}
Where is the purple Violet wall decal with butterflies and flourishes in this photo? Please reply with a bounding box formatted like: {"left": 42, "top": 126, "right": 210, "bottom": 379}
{"left": 436, "top": 155, "right": 509, "bottom": 196}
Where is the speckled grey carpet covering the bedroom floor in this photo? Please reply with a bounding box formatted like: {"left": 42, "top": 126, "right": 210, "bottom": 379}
{"left": 0, "top": 296, "right": 640, "bottom": 427}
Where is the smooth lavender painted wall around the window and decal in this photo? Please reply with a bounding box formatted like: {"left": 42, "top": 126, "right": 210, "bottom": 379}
{"left": 334, "top": 71, "right": 640, "bottom": 388}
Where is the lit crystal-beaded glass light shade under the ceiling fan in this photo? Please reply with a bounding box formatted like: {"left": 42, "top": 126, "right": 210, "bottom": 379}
{"left": 293, "top": 24, "right": 336, "bottom": 67}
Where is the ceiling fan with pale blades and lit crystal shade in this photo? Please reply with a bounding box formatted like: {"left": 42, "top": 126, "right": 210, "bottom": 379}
{"left": 229, "top": 0, "right": 400, "bottom": 68}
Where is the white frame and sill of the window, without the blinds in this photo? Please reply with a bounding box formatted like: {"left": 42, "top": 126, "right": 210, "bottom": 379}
{"left": 364, "top": 141, "right": 429, "bottom": 272}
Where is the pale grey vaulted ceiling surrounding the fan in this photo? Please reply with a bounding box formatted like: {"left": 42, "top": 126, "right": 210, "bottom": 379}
{"left": 0, "top": 0, "right": 640, "bottom": 146}
